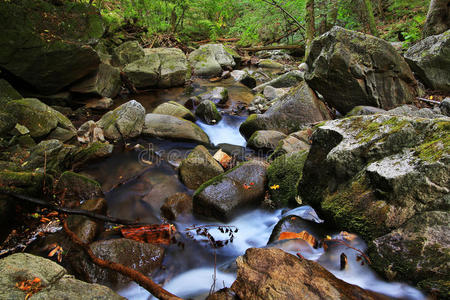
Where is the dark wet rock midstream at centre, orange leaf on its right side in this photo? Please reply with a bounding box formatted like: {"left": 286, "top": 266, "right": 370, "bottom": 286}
{"left": 194, "top": 161, "right": 267, "bottom": 222}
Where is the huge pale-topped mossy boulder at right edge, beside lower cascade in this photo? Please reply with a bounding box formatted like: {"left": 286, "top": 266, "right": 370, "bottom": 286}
{"left": 298, "top": 114, "right": 450, "bottom": 241}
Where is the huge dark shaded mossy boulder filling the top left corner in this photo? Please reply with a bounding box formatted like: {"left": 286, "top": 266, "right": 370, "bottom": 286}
{"left": 0, "top": 0, "right": 104, "bottom": 95}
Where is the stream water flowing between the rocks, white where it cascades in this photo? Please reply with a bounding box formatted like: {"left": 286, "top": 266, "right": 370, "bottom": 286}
{"left": 83, "top": 71, "right": 425, "bottom": 300}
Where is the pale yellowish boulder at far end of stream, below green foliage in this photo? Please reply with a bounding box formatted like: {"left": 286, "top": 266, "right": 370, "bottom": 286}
{"left": 189, "top": 44, "right": 236, "bottom": 77}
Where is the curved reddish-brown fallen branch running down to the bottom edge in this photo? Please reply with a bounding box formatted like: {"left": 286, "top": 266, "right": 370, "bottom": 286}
{"left": 63, "top": 220, "right": 182, "bottom": 300}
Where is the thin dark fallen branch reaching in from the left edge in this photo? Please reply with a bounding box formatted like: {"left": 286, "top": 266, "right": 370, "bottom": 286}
{"left": 0, "top": 191, "right": 149, "bottom": 225}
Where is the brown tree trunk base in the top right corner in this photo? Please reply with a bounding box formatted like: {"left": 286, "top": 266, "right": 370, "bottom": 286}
{"left": 422, "top": 0, "right": 450, "bottom": 38}
